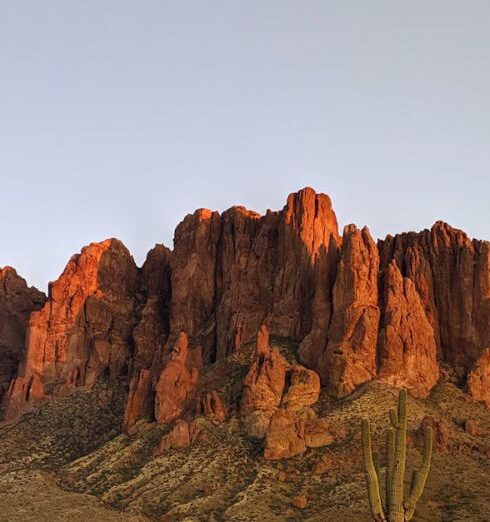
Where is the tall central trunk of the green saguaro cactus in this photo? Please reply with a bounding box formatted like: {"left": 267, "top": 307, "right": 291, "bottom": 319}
{"left": 389, "top": 390, "right": 407, "bottom": 522}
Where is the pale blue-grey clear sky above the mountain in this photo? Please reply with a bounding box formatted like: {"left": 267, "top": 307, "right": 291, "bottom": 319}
{"left": 0, "top": 0, "right": 490, "bottom": 289}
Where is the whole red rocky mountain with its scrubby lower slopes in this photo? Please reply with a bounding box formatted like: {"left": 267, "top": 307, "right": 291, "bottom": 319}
{"left": 0, "top": 188, "right": 490, "bottom": 520}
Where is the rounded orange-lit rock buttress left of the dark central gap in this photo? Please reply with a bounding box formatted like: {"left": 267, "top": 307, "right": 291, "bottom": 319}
{"left": 6, "top": 239, "right": 138, "bottom": 418}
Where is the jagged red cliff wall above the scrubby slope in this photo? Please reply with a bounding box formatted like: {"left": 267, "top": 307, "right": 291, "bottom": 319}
{"left": 0, "top": 189, "right": 490, "bottom": 426}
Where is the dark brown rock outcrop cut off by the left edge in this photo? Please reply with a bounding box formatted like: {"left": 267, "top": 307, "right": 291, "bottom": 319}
{"left": 0, "top": 267, "right": 46, "bottom": 403}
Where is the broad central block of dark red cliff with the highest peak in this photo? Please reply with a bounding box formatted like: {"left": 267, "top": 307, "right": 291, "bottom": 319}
{"left": 170, "top": 185, "right": 340, "bottom": 362}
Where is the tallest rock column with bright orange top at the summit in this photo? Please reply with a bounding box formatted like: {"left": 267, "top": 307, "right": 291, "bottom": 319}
{"left": 271, "top": 187, "right": 340, "bottom": 338}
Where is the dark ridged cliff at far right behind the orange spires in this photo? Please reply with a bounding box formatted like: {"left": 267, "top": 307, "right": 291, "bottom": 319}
{"left": 379, "top": 221, "right": 490, "bottom": 375}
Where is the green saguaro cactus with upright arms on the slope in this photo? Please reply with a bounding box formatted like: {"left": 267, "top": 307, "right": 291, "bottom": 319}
{"left": 361, "top": 390, "right": 432, "bottom": 522}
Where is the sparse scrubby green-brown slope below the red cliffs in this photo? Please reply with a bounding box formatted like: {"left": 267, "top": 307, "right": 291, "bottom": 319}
{"left": 0, "top": 374, "right": 490, "bottom": 522}
